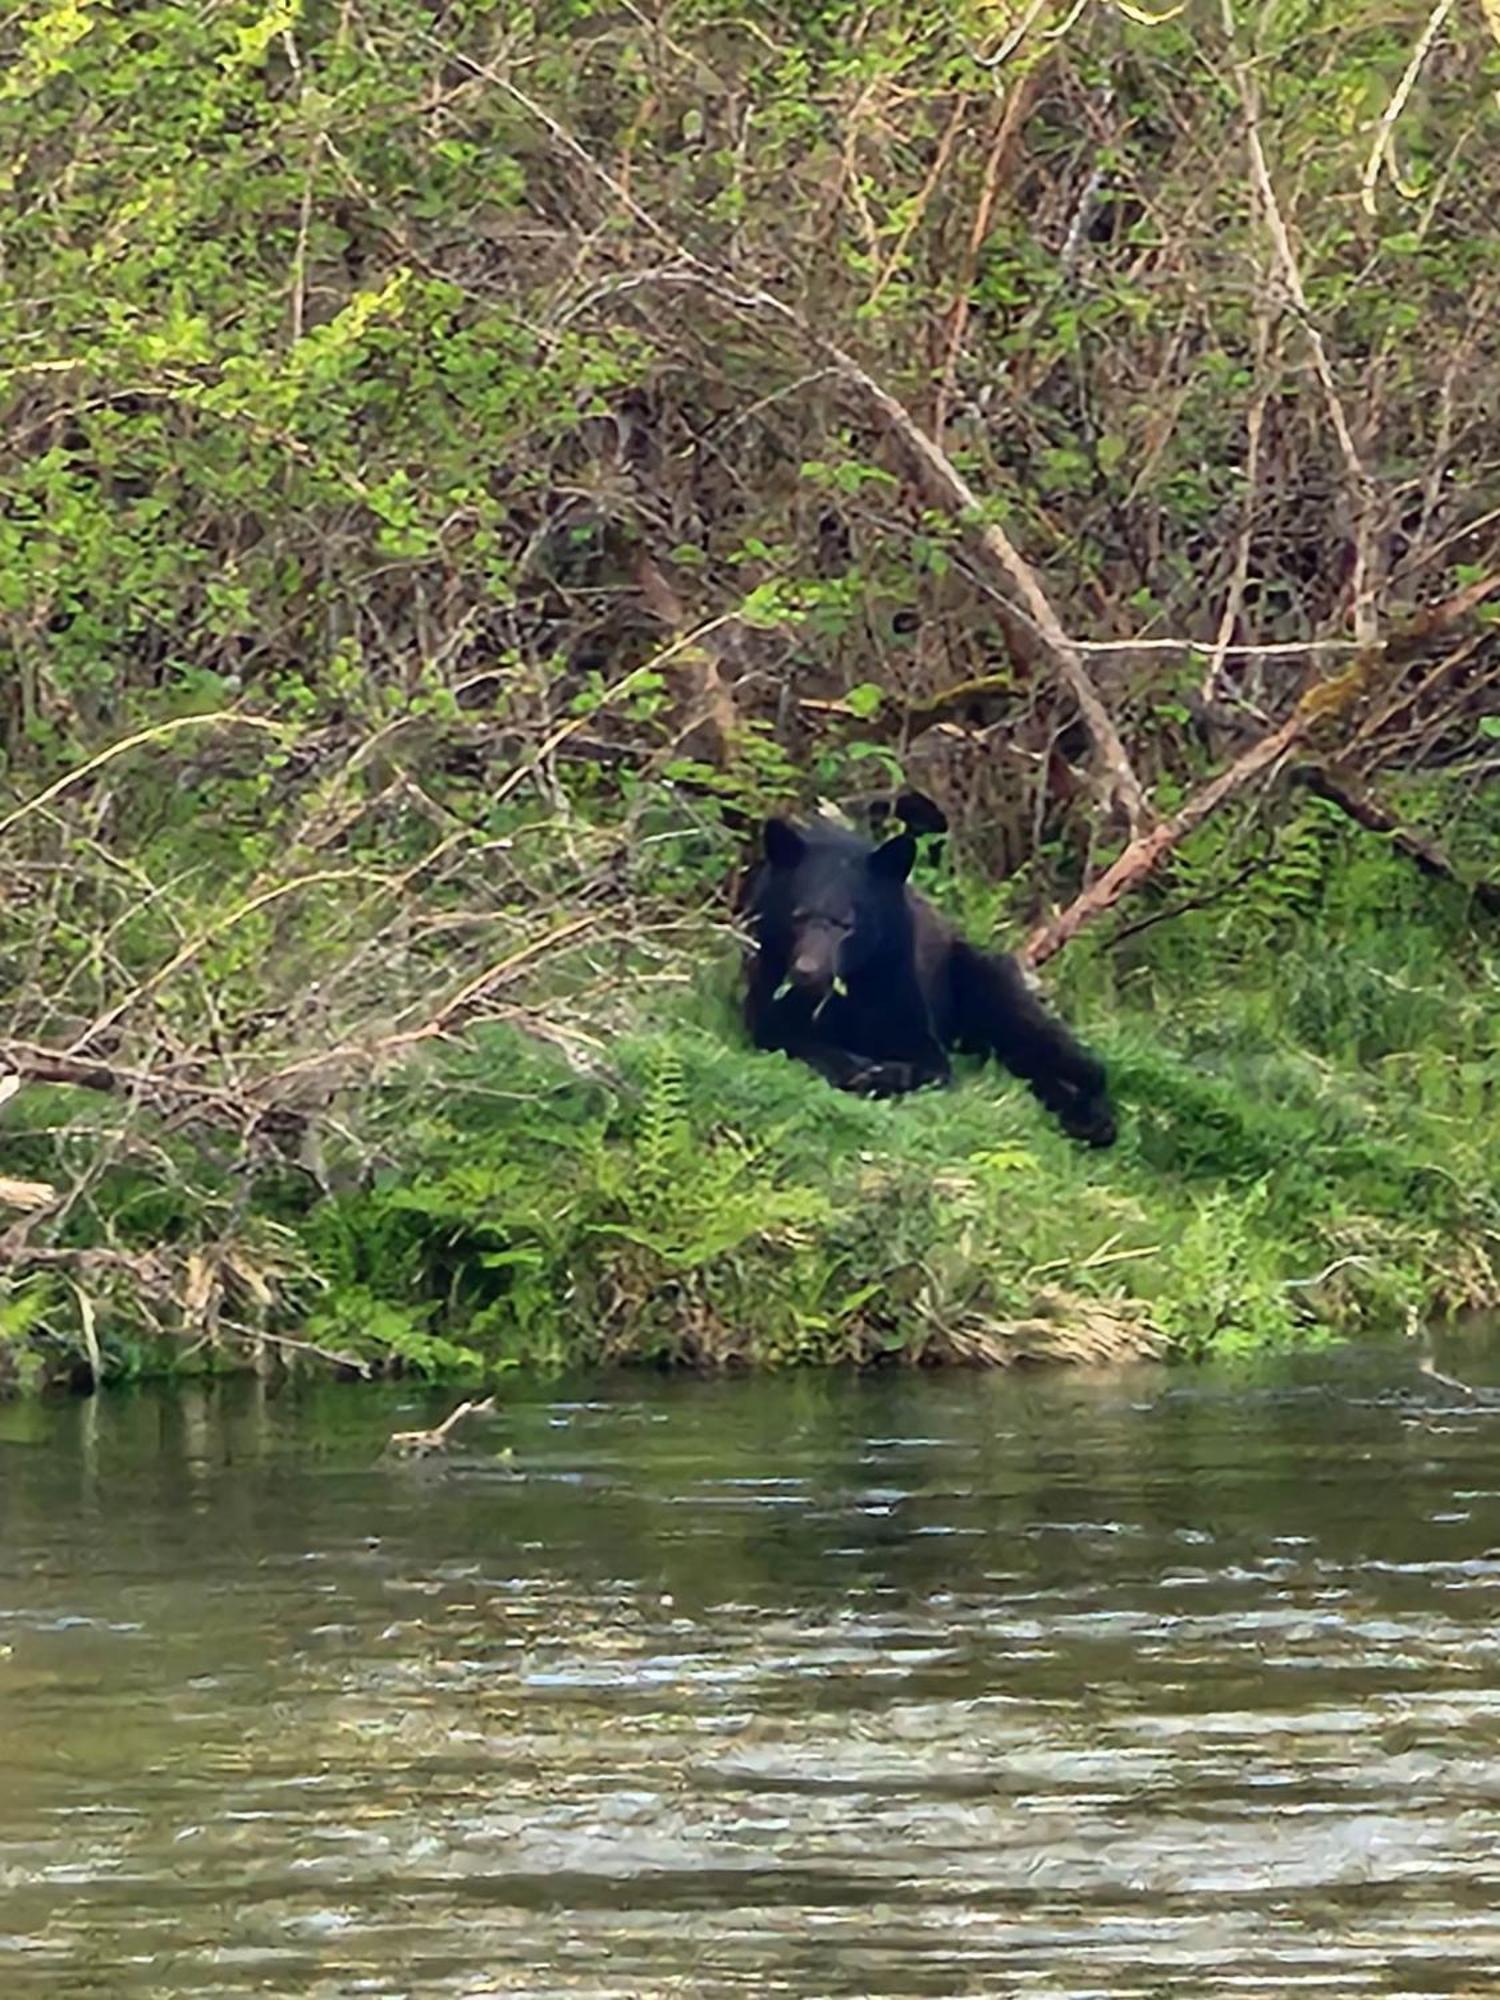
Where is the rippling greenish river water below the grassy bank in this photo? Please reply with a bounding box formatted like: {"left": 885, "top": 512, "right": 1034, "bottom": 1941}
{"left": 0, "top": 1350, "right": 1500, "bottom": 2000}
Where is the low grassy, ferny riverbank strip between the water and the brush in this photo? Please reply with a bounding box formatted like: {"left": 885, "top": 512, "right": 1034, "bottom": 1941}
{"left": 4, "top": 812, "right": 1500, "bottom": 1382}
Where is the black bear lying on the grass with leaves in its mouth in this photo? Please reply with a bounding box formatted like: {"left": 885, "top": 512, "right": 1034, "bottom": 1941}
{"left": 742, "top": 820, "right": 1114, "bottom": 1146}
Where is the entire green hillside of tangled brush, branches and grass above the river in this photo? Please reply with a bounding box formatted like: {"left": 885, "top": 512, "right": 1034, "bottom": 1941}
{"left": 0, "top": 0, "right": 1500, "bottom": 1370}
